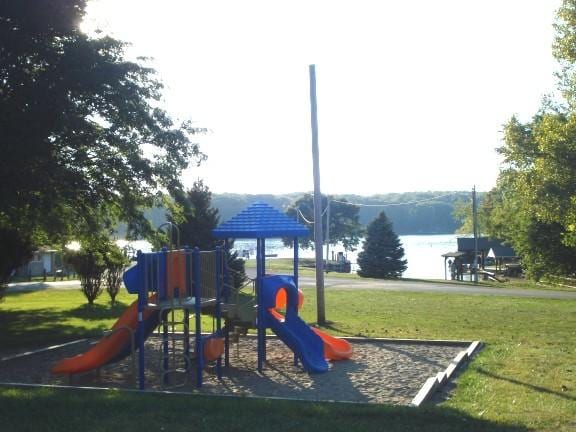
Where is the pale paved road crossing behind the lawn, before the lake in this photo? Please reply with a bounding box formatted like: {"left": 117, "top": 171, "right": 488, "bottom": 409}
{"left": 8, "top": 276, "right": 576, "bottom": 300}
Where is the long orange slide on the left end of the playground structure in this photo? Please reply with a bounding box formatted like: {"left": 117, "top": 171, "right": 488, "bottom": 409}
{"left": 51, "top": 295, "right": 158, "bottom": 375}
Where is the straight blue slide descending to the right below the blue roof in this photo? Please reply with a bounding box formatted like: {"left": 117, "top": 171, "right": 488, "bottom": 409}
{"left": 266, "top": 309, "right": 328, "bottom": 373}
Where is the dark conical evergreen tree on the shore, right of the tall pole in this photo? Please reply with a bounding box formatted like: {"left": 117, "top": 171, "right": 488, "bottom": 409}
{"left": 358, "top": 212, "right": 407, "bottom": 279}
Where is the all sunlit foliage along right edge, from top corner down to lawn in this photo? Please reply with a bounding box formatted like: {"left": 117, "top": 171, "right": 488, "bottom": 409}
{"left": 480, "top": 0, "right": 576, "bottom": 279}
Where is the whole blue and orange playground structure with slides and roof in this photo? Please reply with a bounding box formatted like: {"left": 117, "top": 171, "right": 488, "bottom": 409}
{"left": 52, "top": 203, "right": 352, "bottom": 390}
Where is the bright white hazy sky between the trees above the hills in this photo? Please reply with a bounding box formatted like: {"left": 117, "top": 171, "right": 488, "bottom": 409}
{"left": 86, "top": 0, "right": 561, "bottom": 195}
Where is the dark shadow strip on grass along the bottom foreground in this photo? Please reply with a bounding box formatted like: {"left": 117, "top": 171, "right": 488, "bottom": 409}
{"left": 0, "top": 387, "right": 530, "bottom": 432}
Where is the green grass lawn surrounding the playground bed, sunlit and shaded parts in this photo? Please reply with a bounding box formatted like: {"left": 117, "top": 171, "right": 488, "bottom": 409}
{"left": 0, "top": 289, "right": 576, "bottom": 431}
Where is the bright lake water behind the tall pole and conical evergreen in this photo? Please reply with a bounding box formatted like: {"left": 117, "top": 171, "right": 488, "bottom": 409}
{"left": 234, "top": 234, "right": 458, "bottom": 279}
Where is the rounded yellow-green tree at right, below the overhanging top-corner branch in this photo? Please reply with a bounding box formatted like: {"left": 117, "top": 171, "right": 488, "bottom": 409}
{"left": 480, "top": 118, "right": 576, "bottom": 280}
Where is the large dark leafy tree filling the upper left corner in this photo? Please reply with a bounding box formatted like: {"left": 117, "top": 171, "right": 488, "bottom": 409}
{"left": 0, "top": 0, "right": 203, "bottom": 276}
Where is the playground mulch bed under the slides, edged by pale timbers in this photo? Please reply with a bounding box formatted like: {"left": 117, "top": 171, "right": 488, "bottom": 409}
{"left": 0, "top": 336, "right": 467, "bottom": 405}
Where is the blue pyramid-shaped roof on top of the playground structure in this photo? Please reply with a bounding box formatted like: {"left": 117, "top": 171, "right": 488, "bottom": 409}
{"left": 212, "top": 202, "right": 309, "bottom": 239}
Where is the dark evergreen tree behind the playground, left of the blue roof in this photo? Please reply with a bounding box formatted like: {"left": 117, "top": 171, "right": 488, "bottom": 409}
{"left": 167, "top": 180, "right": 246, "bottom": 288}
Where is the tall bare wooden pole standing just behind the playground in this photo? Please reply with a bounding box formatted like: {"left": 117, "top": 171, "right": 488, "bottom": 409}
{"left": 309, "top": 65, "right": 326, "bottom": 325}
